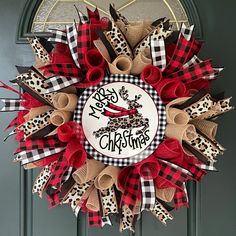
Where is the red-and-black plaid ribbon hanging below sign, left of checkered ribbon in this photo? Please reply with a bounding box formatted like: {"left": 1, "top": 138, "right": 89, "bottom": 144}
{"left": 121, "top": 167, "right": 140, "bottom": 210}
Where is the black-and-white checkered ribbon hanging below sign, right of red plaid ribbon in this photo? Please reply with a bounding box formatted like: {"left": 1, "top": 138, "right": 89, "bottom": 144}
{"left": 140, "top": 168, "right": 156, "bottom": 211}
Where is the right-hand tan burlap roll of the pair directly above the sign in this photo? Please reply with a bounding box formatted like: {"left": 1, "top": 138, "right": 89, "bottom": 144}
{"left": 131, "top": 48, "right": 152, "bottom": 75}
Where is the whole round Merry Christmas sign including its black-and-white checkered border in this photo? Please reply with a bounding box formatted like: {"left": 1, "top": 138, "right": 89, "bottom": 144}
{"left": 74, "top": 75, "right": 166, "bottom": 166}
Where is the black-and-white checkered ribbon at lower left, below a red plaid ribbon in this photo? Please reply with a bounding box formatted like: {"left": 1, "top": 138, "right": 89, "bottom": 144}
{"left": 15, "top": 147, "right": 65, "bottom": 165}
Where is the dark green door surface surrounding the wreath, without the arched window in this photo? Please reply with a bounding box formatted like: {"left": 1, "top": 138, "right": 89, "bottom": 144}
{"left": 0, "top": 0, "right": 236, "bottom": 236}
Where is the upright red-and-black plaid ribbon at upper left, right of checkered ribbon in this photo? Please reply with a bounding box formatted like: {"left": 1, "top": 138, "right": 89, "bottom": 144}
{"left": 77, "top": 23, "right": 91, "bottom": 70}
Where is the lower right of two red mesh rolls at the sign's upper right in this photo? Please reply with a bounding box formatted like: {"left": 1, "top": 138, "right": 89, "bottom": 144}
{"left": 155, "top": 79, "right": 187, "bottom": 103}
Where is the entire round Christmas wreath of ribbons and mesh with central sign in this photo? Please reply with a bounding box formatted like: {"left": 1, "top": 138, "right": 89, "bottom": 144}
{"left": 1, "top": 3, "right": 232, "bottom": 231}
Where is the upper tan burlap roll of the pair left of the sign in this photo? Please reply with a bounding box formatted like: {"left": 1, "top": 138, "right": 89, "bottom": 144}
{"left": 53, "top": 93, "right": 78, "bottom": 112}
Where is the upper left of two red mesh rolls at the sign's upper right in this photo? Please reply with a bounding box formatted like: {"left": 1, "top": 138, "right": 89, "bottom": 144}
{"left": 140, "top": 65, "right": 162, "bottom": 87}
